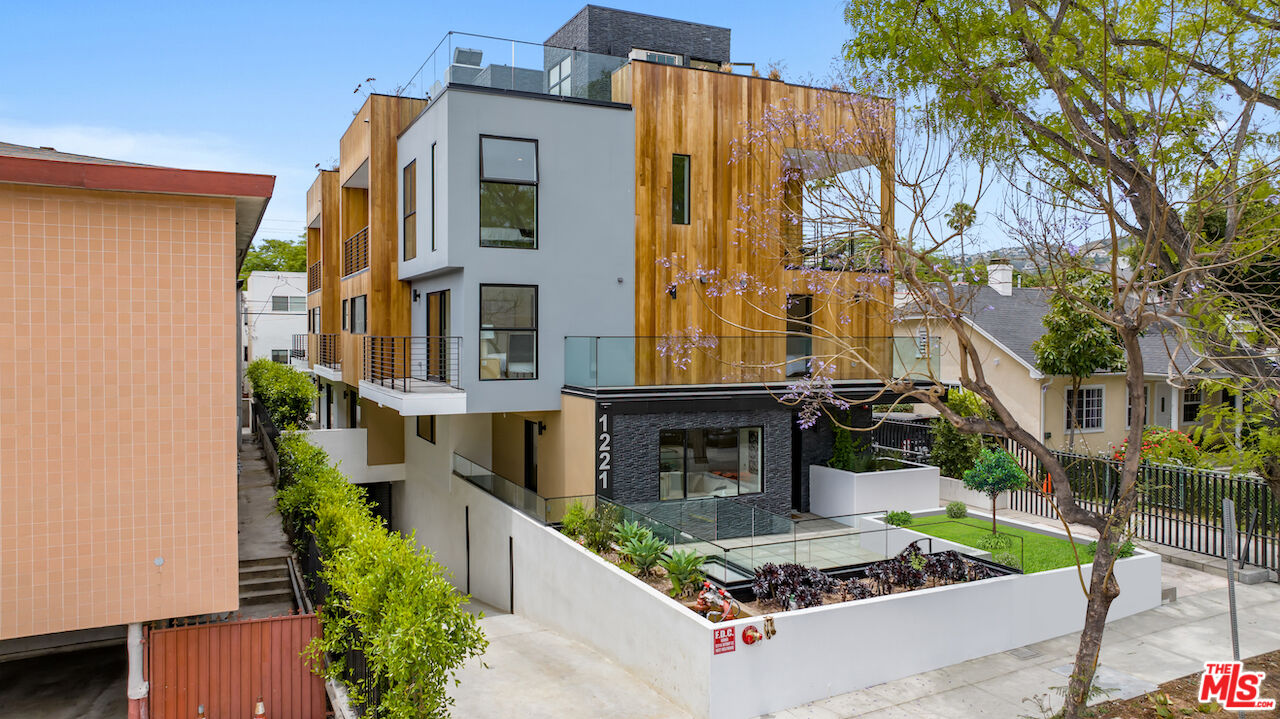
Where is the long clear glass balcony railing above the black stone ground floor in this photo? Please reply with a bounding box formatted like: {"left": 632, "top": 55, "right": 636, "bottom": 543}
{"left": 564, "top": 334, "right": 941, "bottom": 389}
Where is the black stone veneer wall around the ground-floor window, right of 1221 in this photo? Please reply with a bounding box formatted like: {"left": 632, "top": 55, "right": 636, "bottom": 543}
{"left": 611, "top": 408, "right": 788, "bottom": 514}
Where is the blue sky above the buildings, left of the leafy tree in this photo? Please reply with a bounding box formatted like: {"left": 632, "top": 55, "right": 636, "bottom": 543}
{"left": 0, "top": 0, "right": 931, "bottom": 248}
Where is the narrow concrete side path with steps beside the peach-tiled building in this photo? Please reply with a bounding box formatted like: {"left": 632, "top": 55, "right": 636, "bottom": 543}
{"left": 237, "top": 427, "right": 294, "bottom": 618}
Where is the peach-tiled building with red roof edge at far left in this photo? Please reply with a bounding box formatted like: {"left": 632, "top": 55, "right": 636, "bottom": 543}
{"left": 0, "top": 143, "right": 275, "bottom": 699}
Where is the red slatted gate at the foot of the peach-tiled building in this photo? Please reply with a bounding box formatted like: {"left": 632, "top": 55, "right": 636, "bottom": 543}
{"left": 147, "top": 614, "right": 325, "bottom": 719}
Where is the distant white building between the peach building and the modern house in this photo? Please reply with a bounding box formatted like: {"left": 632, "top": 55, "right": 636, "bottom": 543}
{"left": 241, "top": 271, "right": 308, "bottom": 365}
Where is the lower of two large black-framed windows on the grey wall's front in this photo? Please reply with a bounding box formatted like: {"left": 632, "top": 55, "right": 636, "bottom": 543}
{"left": 480, "top": 284, "right": 538, "bottom": 380}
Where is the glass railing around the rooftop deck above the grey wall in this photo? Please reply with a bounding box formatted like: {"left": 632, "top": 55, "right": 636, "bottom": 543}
{"left": 398, "top": 32, "right": 627, "bottom": 101}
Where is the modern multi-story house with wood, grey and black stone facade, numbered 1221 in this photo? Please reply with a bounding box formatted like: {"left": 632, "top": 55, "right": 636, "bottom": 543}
{"left": 307, "top": 6, "right": 914, "bottom": 593}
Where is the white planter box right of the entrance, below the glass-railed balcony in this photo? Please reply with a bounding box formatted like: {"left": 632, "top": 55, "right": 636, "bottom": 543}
{"left": 809, "top": 462, "right": 938, "bottom": 517}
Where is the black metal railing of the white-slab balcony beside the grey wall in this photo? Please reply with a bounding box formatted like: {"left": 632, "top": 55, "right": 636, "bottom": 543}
{"left": 364, "top": 336, "right": 462, "bottom": 391}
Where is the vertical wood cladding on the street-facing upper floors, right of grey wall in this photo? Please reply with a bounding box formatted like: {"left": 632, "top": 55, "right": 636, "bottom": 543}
{"left": 624, "top": 61, "right": 893, "bottom": 383}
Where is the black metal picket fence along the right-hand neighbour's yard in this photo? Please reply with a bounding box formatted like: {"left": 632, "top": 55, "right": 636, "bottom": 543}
{"left": 1004, "top": 440, "right": 1280, "bottom": 571}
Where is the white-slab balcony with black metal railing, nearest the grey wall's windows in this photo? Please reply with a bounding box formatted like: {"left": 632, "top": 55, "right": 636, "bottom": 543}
{"left": 360, "top": 336, "right": 467, "bottom": 417}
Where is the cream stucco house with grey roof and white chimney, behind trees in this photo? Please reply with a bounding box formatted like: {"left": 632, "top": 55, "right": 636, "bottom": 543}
{"left": 900, "top": 264, "right": 1238, "bottom": 454}
